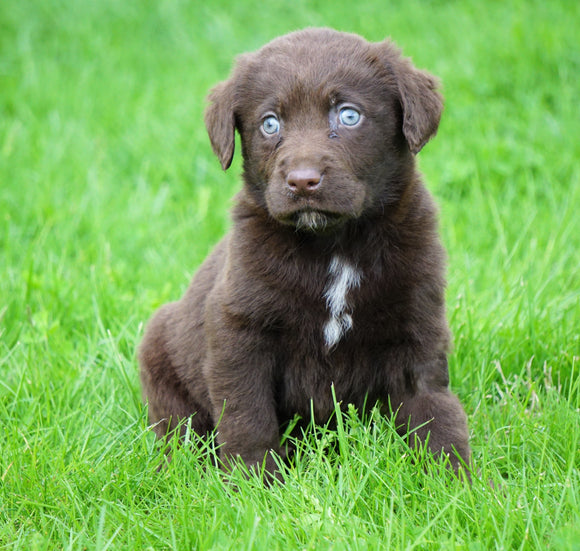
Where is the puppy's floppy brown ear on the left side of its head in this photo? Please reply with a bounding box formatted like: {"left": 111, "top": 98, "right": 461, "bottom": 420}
{"left": 204, "top": 79, "right": 236, "bottom": 170}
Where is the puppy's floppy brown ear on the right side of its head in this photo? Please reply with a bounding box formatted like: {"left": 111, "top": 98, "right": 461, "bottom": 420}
{"left": 378, "top": 40, "right": 443, "bottom": 153}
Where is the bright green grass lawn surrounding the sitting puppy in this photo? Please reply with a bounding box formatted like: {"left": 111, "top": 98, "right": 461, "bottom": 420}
{"left": 0, "top": 0, "right": 580, "bottom": 550}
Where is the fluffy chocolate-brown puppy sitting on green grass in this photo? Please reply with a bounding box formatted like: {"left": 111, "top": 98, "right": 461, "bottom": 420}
{"left": 139, "top": 29, "right": 470, "bottom": 473}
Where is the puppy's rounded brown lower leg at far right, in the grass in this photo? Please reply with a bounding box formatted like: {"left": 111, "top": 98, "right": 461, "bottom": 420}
{"left": 393, "top": 388, "right": 471, "bottom": 472}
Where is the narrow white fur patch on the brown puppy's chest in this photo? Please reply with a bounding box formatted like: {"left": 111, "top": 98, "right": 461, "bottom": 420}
{"left": 324, "top": 256, "right": 361, "bottom": 349}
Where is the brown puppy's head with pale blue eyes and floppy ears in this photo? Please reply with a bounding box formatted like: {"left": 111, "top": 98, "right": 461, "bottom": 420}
{"left": 205, "top": 29, "right": 442, "bottom": 232}
